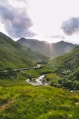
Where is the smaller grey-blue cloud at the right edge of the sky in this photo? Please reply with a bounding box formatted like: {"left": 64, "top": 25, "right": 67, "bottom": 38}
{"left": 61, "top": 17, "right": 79, "bottom": 35}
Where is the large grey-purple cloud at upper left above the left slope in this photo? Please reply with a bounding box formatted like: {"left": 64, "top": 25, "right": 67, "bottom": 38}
{"left": 0, "top": 0, "right": 34, "bottom": 38}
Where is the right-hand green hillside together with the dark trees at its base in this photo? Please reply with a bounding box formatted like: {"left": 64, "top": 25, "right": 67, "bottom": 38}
{"left": 48, "top": 46, "right": 79, "bottom": 90}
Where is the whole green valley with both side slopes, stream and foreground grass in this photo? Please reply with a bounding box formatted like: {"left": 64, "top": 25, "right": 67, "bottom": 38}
{"left": 0, "top": 33, "right": 79, "bottom": 119}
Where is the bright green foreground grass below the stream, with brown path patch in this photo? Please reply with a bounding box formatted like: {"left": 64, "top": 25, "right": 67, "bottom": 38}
{"left": 0, "top": 79, "right": 79, "bottom": 119}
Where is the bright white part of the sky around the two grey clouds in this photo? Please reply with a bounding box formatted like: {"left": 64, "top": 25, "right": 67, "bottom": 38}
{"left": 0, "top": 0, "right": 79, "bottom": 43}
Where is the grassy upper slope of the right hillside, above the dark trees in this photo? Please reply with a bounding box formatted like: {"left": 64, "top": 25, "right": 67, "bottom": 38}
{"left": 49, "top": 46, "right": 79, "bottom": 69}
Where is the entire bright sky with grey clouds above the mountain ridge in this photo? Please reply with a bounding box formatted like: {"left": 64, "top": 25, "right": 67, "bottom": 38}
{"left": 0, "top": 0, "right": 79, "bottom": 44}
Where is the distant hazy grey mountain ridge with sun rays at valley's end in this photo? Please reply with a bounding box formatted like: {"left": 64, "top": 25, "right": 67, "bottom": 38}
{"left": 17, "top": 38, "right": 76, "bottom": 58}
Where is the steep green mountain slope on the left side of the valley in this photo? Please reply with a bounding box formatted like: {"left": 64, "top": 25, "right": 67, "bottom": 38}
{"left": 0, "top": 33, "right": 47, "bottom": 68}
